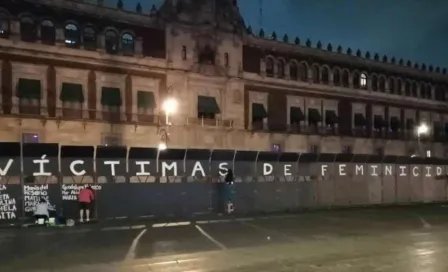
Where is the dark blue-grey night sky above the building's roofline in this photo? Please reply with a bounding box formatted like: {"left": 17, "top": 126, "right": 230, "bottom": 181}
{"left": 106, "top": 0, "right": 448, "bottom": 67}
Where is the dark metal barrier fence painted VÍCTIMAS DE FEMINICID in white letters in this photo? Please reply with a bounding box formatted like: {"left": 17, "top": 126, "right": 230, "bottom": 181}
{"left": 0, "top": 143, "right": 448, "bottom": 221}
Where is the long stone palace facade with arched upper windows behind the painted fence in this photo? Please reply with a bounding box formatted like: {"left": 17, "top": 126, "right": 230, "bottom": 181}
{"left": 0, "top": 0, "right": 448, "bottom": 156}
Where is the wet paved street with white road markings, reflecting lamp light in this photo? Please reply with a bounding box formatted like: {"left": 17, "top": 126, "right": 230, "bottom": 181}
{"left": 0, "top": 205, "right": 448, "bottom": 272}
